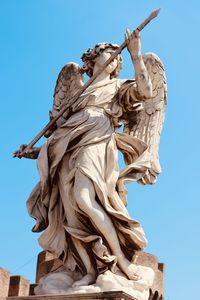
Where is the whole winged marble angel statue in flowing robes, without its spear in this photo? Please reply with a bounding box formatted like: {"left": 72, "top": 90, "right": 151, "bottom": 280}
{"left": 15, "top": 26, "right": 166, "bottom": 293}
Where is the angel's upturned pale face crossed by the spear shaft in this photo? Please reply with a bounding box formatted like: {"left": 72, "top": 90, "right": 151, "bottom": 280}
{"left": 95, "top": 48, "right": 118, "bottom": 74}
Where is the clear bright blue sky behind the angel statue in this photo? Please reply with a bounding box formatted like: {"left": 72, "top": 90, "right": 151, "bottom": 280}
{"left": 0, "top": 0, "right": 200, "bottom": 300}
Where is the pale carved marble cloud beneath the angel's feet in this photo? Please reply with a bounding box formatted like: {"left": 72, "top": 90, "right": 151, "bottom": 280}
{"left": 35, "top": 266, "right": 154, "bottom": 300}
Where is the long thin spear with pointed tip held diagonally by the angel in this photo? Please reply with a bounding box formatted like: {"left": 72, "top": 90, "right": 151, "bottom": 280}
{"left": 14, "top": 9, "right": 160, "bottom": 157}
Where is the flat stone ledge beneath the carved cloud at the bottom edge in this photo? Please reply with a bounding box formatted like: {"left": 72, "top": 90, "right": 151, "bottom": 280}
{"left": 7, "top": 291, "right": 137, "bottom": 300}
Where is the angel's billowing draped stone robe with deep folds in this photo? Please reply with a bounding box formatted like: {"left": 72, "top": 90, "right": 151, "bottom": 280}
{"left": 27, "top": 79, "right": 152, "bottom": 274}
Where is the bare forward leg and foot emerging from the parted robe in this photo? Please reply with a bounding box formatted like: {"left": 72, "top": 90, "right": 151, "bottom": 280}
{"left": 74, "top": 170, "right": 139, "bottom": 280}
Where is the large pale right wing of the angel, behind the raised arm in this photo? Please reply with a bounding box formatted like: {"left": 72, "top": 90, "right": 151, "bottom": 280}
{"left": 125, "top": 53, "right": 167, "bottom": 184}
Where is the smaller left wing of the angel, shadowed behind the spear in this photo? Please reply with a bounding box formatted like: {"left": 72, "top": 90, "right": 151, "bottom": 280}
{"left": 52, "top": 62, "right": 84, "bottom": 126}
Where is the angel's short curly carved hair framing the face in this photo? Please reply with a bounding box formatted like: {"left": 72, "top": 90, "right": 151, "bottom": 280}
{"left": 81, "top": 43, "right": 122, "bottom": 79}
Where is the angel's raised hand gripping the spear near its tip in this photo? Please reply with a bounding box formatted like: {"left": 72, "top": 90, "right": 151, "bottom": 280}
{"left": 125, "top": 29, "right": 141, "bottom": 58}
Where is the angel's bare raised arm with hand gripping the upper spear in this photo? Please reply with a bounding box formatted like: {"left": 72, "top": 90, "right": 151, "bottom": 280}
{"left": 125, "top": 30, "right": 152, "bottom": 99}
